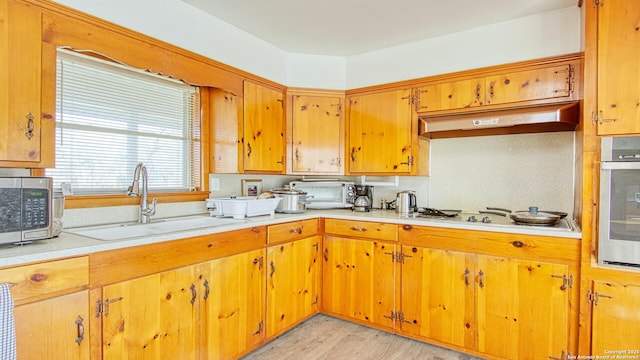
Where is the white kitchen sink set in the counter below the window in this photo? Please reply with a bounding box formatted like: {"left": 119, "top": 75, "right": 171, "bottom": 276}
{"left": 64, "top": 215, "right": 246, "bottom": 241}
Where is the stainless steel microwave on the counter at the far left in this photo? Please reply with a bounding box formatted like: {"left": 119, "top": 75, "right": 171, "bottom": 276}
{"left": 0, "top": 177, "right": 53, "bottom": 244}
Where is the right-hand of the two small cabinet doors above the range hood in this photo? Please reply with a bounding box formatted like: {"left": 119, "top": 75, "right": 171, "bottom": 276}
{"left": 485, "top": 65, "right": 573, "bottom": 104}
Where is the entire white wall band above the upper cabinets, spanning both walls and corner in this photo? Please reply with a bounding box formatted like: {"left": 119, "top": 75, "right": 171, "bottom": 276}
{"left": 51, "top": 0, "right": 580, "bottom": 90}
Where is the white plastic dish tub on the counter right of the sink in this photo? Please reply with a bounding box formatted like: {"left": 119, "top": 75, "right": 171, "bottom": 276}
{"left": 207, "top": 196, "right": 280, "bottom": 220}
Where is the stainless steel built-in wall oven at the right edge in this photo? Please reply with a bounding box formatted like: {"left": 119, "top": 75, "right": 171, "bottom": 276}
{"left": 598, "top": 137, "right": 640, "bottom": 267}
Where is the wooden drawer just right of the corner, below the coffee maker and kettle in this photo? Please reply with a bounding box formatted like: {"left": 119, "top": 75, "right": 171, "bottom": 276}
{"left": 324, "top": 219, "right": 398, "bottom": 241}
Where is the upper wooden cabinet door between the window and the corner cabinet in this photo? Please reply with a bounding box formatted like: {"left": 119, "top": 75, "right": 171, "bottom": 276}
{"left": 243, "top": 81, "right": 285, "bottom": 173}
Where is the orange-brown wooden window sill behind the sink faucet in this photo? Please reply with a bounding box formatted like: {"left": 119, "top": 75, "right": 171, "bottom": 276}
{"left": 64, "top": 191, "right": 209, "bottom": 209}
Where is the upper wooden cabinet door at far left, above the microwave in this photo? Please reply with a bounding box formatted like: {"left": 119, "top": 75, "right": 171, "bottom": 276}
{"left": 0, "top": 0, "right": 42, "bottom": 166}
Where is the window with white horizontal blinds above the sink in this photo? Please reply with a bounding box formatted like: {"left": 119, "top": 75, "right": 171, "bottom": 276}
{"left": 46, "top": 49, "right": 200, "bottom": 195}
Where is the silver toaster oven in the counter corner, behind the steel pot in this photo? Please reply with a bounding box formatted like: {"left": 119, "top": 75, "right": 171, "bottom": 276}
{"left": 289, "top": 180, "right": 356, "bottom": 209}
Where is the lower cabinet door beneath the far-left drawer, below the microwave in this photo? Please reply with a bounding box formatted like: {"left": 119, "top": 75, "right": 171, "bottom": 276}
{"left": 14, "top": 290, "right": 89, "bottom": 360}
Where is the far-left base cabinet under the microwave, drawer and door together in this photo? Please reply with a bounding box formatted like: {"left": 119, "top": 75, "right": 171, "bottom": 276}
{"left": 0, "top": 257, "right": 91, "bottom": 360}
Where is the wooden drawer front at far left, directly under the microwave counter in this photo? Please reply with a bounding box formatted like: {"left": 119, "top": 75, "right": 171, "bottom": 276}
{"left": 0, "top": 256, "right": 89, "bottom": 302}
